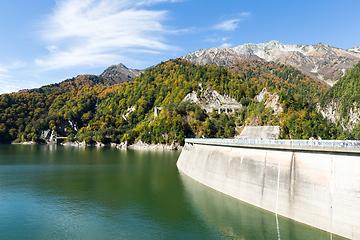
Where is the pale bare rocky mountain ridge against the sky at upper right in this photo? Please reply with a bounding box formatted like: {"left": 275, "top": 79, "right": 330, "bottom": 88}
{"left": 183, "top": 41, "right": 360, "bottom": 85}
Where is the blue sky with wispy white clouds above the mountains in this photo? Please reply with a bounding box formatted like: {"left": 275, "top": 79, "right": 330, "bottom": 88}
{"left": 0, "top": 0, "right": 360, "bottom": 94}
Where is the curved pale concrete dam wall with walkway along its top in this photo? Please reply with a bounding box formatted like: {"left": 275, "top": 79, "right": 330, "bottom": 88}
{"left": 177, "top": 139, "right": 360, "bottom": 239}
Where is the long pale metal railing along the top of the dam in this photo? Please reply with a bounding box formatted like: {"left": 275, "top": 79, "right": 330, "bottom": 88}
{"left": 185, "top": 138, "right": 360, "bottom": 148}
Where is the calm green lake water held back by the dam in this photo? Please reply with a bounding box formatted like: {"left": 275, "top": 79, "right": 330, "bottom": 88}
{"left": 0, "top": 145, "right": 339, "bottom": 240}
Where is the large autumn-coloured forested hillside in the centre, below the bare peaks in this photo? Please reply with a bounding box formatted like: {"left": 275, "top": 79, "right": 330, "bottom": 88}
{"left": 0, "top": 59, "right": 348, "bottom": 144}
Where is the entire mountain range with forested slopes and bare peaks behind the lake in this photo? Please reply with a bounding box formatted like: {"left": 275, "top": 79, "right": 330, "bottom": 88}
{"left": 0, "top": 41, "right": 360, "bottom": 145}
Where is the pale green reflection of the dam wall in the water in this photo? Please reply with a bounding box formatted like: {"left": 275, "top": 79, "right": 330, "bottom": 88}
{"left": 180, "top": 173, "right": 342, "bottom": 240}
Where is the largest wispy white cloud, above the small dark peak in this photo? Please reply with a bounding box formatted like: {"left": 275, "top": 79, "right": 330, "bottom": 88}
{"left": 35, "top": 0, "right": 175, "bottom": 70}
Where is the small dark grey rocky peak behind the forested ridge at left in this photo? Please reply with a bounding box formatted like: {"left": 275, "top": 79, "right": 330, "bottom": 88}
{"left": 100, "top": 63, "right": 143, "bottom": 84}
